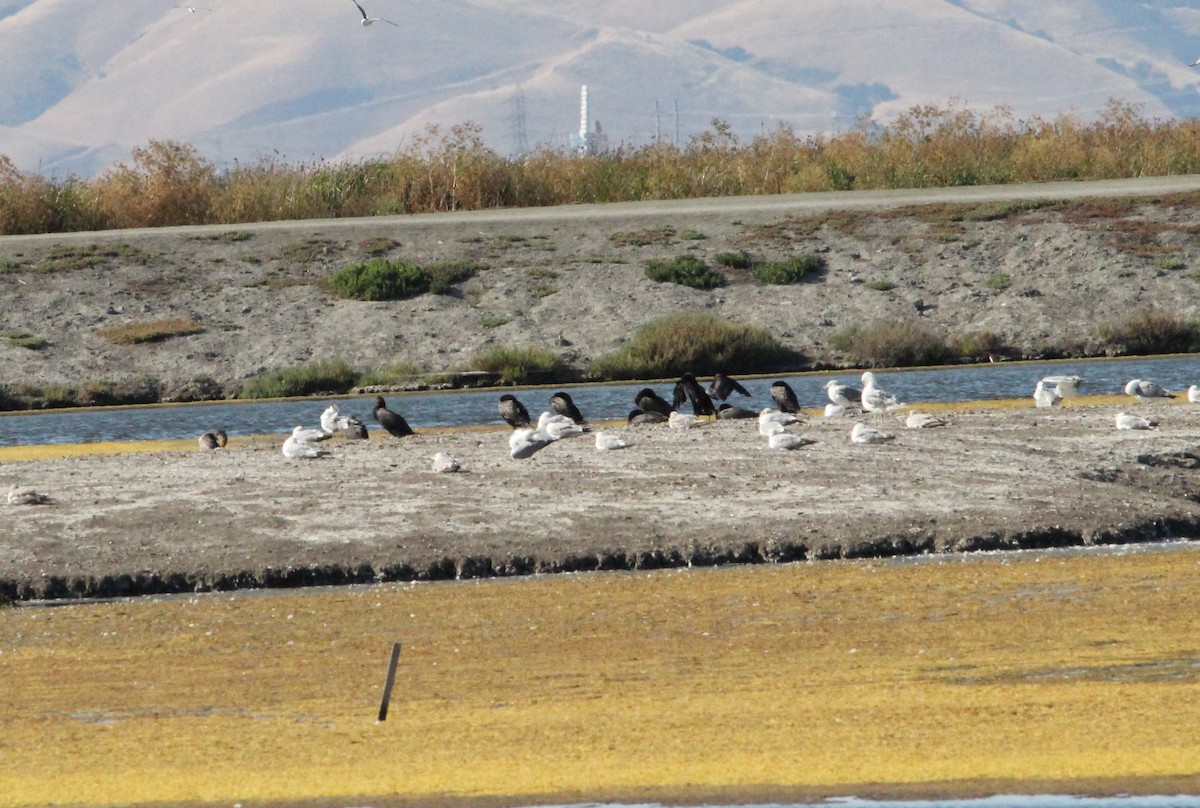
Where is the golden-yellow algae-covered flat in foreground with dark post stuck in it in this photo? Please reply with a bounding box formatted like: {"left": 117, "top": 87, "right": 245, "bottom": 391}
{"left": 0, "top": 546, "right": 1200, "bottom": 806}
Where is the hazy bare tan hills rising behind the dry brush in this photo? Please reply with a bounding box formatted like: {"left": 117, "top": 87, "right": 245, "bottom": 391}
{"left": 0, "top": 0, "right": 1200, "bottom": 175}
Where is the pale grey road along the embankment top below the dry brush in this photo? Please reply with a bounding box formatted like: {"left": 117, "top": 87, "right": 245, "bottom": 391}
{"left": 7, "top": 174, "right": 1200, "bottom": 243}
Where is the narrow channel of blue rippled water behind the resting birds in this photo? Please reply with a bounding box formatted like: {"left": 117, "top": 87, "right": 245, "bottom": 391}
{"left": 0, "top": 354, "right": 1200, "bottom": 445}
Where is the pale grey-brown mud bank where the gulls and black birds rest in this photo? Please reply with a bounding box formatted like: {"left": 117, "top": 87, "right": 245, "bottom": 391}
{"left": 0, "top": 399, "right": 1200, "bottom": 598}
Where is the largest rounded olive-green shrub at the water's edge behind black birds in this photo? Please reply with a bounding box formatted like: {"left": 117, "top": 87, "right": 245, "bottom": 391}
{"left": 589, "top": 312, "right": 803, "bottom": 379}
